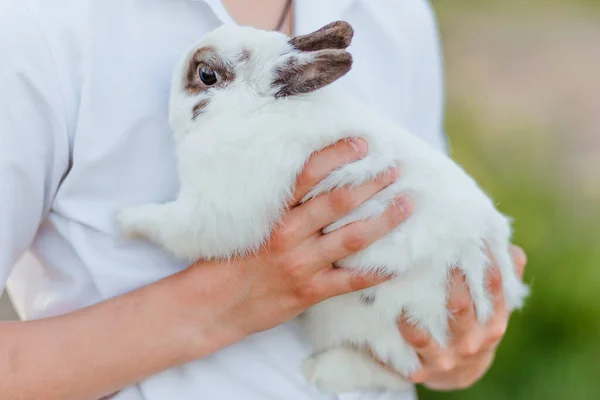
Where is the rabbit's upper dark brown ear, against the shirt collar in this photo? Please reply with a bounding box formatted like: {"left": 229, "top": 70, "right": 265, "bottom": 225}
{"left": 290, "top": 21, "right": 354, "bottom": 51}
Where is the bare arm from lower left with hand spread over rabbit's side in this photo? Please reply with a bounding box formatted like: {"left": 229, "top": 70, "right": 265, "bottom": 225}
{"left": 0, "top": 140, "right": 409, "bottom": 400}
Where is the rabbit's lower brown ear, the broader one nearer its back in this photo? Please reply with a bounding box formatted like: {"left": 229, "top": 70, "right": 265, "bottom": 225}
{"left": 271, "top": 49, "right": 352, "bottom": 98}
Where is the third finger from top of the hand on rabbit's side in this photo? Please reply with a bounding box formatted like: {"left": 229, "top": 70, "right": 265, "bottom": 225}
{"left": 320, "top": 196, "right": 413, "bottom": 263}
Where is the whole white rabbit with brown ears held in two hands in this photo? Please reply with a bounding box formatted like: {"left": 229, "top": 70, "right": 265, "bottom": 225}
{"left": 118, "top": 22, "right": 528, "bottom": 393}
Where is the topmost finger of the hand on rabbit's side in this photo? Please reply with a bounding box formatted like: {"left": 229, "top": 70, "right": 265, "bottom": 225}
{"left": 292, "top": 138, "right": 368, "bottom": 206}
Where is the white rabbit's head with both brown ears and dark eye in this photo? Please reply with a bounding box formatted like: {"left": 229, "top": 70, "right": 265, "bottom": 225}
{"left": 170, "top": 21, "right": 353, "bottom": 134}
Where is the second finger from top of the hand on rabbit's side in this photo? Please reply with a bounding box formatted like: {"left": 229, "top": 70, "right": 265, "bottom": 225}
{"left": 285, "top": 169, "right": 398, "bottom": 237}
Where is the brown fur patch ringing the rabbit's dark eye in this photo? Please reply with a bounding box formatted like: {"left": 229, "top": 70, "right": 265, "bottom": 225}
{"left": 183, "top": 46, "right": 235, "bottom": 95}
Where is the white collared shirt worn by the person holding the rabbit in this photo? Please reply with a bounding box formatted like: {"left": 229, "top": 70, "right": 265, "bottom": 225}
{"left": 0, "top": 0, "right": 444, "bottom": 400}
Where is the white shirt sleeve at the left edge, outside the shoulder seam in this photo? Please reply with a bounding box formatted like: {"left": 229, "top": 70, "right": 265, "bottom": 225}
{"left": 0, "top": 0, "right": 69, "bottom": 293}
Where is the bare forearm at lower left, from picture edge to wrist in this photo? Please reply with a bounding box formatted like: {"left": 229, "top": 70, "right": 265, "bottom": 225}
{"left": 0, "top": 266, "right": 238, "bottom": 400}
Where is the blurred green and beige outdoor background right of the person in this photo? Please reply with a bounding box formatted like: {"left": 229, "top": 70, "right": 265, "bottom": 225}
{"left": 419, "top": 0, "right": 600, "bottom": 400}
